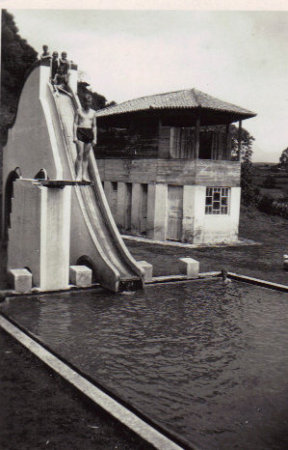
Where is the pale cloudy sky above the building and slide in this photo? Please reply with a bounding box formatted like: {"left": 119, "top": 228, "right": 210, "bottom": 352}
{"left": 6, "top": 7, "right": 288, "bottom": 162}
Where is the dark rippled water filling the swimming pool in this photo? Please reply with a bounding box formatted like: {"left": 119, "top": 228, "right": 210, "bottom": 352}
{"left": 2, "top": 280, "right": 288, "bottom": 450}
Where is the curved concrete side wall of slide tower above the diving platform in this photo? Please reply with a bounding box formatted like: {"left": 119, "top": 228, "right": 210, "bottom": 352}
{"left": 2, "top": 66, "right": 62, "bottom": 237}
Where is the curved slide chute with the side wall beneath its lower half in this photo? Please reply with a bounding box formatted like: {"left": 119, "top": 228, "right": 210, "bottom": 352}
{"left": 49, "top": 86, "right": 143, "bottom": 291}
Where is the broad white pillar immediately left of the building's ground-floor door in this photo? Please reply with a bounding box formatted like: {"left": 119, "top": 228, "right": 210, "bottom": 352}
{"left": 147, "top": 183, "right": 168, "bottom": 241}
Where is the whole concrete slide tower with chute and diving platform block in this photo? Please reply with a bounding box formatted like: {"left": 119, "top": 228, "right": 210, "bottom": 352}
{"left": 2, "top": 62, "right": 144, "bottom": 292}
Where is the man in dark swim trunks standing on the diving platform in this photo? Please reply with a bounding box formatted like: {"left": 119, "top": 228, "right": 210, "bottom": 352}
{"left": 73, "top": 93, "right": 97, "bottom": 181}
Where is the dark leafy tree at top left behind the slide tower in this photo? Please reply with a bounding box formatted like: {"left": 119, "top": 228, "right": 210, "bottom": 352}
{"left": 0, "top": 9, "right": 37, "bottom": 145}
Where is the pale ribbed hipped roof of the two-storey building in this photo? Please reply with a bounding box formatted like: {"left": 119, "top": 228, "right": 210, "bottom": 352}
{"left": 96, "top": 89, "right": 256, "bottom": 118}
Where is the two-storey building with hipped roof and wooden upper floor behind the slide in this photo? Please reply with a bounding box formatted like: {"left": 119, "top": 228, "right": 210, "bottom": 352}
{"left": 96, "top": 89, "right": 255, "bottom": 244}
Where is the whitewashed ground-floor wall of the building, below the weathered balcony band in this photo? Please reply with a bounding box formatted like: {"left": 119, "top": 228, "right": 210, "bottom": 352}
{"left": 105, "top": 178, "right": 241, "bottom": 244}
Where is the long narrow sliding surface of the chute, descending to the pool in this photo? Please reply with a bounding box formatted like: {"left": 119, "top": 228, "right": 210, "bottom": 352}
{"left": 50, "top": 89, "right": 143, "bottom": 289}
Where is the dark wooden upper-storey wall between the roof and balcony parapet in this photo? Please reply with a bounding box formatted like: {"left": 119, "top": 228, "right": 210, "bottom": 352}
{"left": 95, "top": 120, "right": 231, "bottom": 160}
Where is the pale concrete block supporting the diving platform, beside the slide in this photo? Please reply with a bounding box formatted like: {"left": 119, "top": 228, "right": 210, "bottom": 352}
{"left": 8, "top": 180, "right": 71, "bottom": 290}
